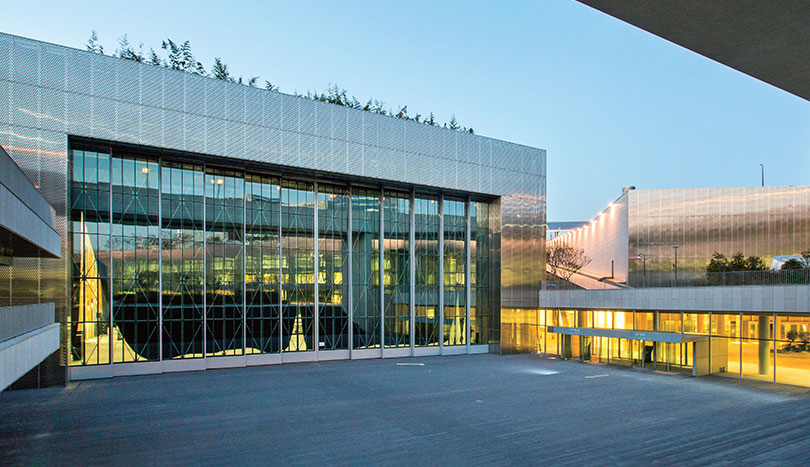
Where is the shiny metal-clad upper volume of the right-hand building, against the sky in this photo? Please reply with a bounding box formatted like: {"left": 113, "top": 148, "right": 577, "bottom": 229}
{"left": 549, "top": 186, "right": 810, "bottom": 289}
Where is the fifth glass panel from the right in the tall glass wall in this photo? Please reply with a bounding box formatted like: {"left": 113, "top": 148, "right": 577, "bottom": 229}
{"left": 351, "top": 188, "right": 380, "bottom": 349}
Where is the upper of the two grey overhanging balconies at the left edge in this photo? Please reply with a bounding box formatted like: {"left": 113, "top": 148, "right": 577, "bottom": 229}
{"left": 0, "top": 147, "right": 61, "bottom": 258}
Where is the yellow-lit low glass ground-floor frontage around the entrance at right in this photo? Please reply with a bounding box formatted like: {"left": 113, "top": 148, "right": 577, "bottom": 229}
{"left": 534, "top": 310, "right": 810, "bottom": 386}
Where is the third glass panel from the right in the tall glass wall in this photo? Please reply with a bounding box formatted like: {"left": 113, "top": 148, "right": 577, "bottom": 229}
{"left": 414, "top": 196, "right": 440, "bottom": 346}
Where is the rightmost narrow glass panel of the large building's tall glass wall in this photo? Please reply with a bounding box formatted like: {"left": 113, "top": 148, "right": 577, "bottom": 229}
{"left": 470, "top": 201, "right": 492, "bottom": 345}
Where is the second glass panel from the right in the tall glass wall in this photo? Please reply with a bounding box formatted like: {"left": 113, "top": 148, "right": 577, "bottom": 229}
{"left": 442, "top": 199, "right": 467, "bottom": 346}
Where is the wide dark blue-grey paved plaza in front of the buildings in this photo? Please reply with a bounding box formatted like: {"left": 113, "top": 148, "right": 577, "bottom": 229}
{"left": 0, "top": 355, "right": 810, "bottom": 465}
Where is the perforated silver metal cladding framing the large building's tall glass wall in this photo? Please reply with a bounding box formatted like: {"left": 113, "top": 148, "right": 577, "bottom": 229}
{"left": 0, "top": 34, "right": 546, "bottom": 384}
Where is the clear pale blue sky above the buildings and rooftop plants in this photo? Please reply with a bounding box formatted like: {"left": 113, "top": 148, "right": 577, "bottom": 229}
{"left": 0, "top": 0, "right": 810, "bottom": 221}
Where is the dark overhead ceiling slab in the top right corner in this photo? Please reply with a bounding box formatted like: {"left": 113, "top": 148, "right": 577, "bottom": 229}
{"left": 578, "top": 0, "right": 810, "bottom": 100}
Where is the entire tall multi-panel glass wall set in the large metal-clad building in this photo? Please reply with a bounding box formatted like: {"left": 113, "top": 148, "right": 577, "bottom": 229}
{"left": 68, "top": 143, "right": 499, "bottom": 366}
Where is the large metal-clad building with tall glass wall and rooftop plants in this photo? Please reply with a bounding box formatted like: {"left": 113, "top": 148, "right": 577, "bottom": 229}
{"left": 0, "top": 34, "right": 546, "bottom": 384}
